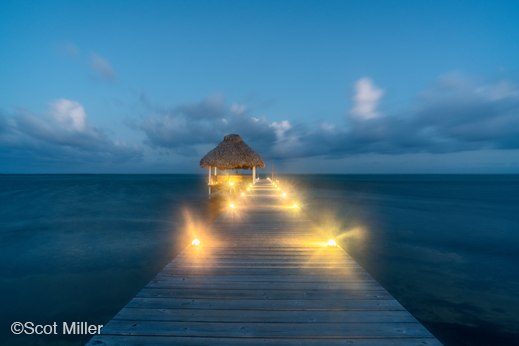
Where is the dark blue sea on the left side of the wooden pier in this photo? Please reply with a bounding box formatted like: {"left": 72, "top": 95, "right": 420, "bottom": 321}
{"left": 0, "top": 175, "right": 210, "bottom": 345}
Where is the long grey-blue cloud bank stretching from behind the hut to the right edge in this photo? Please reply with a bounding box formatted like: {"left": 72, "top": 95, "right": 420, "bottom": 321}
{"left": 136, "top": 75, "right": 519, "bottom": 159}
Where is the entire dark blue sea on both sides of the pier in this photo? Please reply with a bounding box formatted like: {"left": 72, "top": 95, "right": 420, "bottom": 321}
{"left": 0, "top": 175, "right": 519, "bottom": 346}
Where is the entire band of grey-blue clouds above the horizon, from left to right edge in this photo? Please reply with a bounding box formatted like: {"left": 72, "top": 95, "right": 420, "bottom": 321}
{"left": 4, "top": 75, "right": 519, "bottom": 173}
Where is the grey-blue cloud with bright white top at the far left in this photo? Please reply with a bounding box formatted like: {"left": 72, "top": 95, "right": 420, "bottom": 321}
{"left": 0, "top": 99, "right": 142, "bottom": 162}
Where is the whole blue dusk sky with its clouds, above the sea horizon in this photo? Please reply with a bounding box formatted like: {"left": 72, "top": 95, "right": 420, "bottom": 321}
{"left": 0, "top": 1, "right": 519, "bottom": 173}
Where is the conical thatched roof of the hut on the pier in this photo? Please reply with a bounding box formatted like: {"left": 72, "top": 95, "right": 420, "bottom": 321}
{"left": 200, "top": 135, "right": 265, "bottom": 170}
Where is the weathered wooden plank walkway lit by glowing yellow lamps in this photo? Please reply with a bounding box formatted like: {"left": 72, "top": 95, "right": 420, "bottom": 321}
{"left": 87, "top": 181, "right": 441, "bottom": 346}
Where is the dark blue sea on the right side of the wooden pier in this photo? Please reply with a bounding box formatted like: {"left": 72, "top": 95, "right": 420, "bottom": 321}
{"left": 290, "top": 175, "right": 519, "bottom": 346}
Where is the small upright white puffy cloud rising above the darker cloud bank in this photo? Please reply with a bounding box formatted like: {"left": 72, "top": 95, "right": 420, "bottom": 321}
{"left": 350, "top": 78, "right": 385, "bottom": 119}
